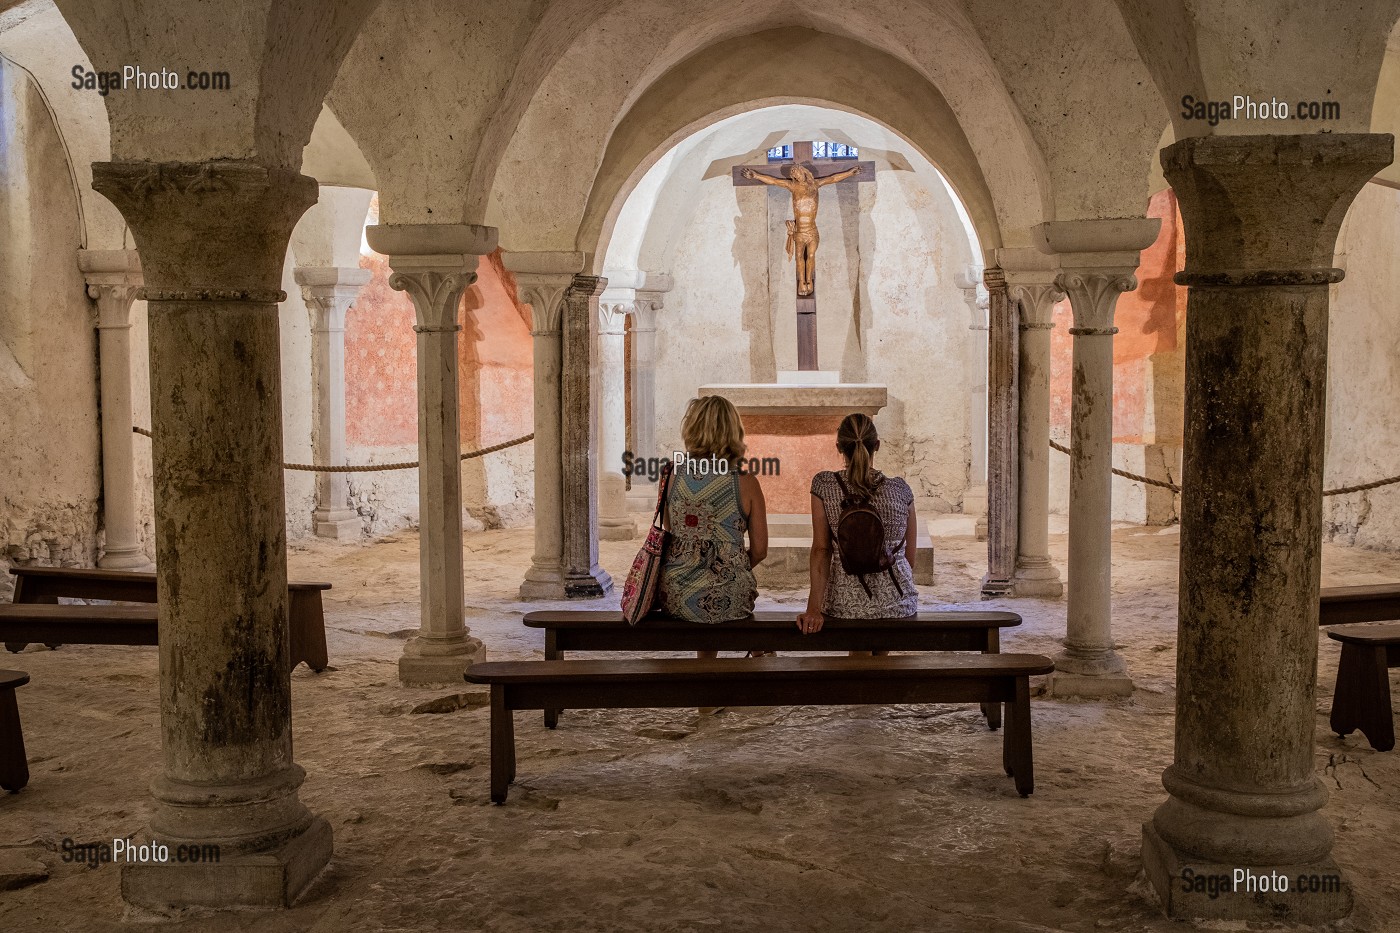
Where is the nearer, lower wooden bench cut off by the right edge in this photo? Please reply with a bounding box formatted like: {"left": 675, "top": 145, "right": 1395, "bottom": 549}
{"left": 1327, "top": 622, "right": 1400, "bottom": 751}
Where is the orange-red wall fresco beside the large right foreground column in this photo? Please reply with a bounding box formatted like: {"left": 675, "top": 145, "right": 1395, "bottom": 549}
{"left": 1050, "top": 189, "right": 1186, "bottom": 444}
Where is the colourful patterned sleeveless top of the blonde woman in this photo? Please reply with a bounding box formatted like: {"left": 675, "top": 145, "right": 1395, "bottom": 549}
{"left": 661, "top": 468, "right": 759, "bottom": 622}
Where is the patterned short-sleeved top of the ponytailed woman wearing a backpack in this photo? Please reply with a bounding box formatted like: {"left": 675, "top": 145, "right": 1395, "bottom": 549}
{"left": 812, "top": 469, "right": 918, "bottom": 619}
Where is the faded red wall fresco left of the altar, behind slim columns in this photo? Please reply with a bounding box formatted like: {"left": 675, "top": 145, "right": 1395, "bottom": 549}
{"left": 346, "top": 226, "right": 533, "bottom": 447}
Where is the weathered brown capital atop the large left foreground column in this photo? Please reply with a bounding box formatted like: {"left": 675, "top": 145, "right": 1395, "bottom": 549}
{"left": 92, "top": 160, "right": 316, "bottom": 292}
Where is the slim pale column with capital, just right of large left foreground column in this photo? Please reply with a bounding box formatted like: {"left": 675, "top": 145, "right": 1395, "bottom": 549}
{"left": 294, "top": 266, "right": 370, "bottom": 541}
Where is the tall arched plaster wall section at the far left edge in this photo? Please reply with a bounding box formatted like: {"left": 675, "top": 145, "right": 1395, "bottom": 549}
{"left": 0, "top": 59, "right": 101, "bottom": 598}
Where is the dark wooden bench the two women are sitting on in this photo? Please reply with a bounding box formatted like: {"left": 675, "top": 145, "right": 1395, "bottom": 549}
{"left": 525, "top": 609, "right": 1021, "bottom": 728}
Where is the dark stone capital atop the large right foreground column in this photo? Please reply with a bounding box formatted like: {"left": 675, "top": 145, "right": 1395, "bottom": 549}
{"left": 1161, "top": 133, "right": 1394, "bottom": 286}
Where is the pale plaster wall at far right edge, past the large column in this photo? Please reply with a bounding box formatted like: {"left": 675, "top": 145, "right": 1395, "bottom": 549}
{"left": 1323, "top": 177, "right": 1400, "bottom": 551}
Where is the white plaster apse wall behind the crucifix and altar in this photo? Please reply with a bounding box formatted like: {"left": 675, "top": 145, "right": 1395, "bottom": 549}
{"left": 649, "top": 114, "right": 976, "bottom": 513}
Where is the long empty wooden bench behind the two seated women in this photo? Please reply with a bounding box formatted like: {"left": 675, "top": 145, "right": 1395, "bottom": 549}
{"left": 465, "top": 654, "right": 1054, "bottom": 804}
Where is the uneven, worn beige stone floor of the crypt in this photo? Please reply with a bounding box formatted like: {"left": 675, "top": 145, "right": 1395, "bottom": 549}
{"left": 0, "top": 527, "right": 1400, "bottom": 933}
